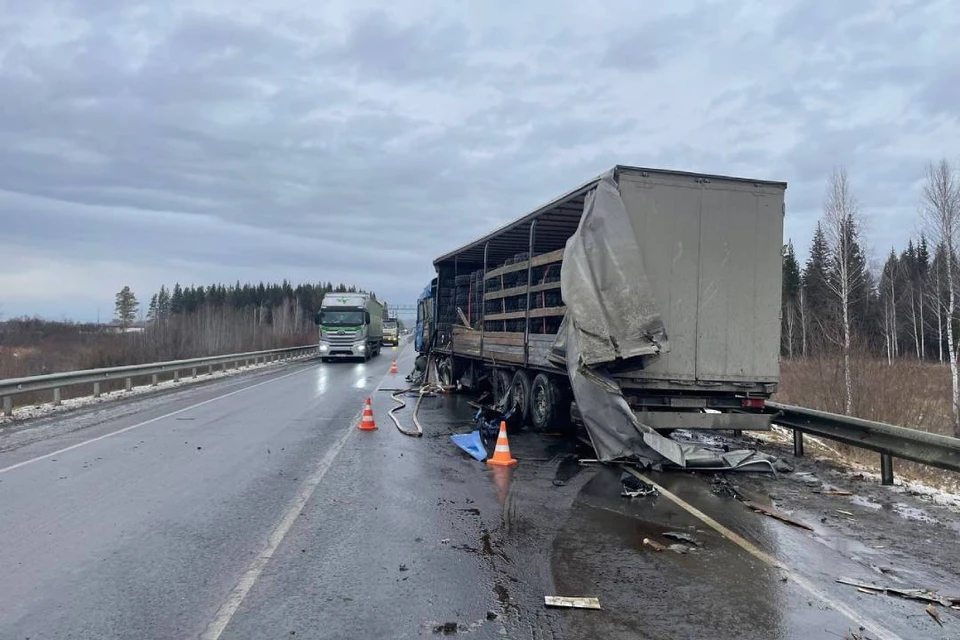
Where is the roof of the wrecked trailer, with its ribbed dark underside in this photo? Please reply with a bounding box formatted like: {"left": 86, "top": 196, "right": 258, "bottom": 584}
{"left": 433, "top": 165, "right": 787, "bottom": 267}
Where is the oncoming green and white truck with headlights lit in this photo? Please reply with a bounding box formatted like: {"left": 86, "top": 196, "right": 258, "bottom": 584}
{"left": 314, "top": 293, "right": 383, "bottom": 362}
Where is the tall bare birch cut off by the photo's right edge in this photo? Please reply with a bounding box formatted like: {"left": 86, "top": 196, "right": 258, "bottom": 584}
{"left": 920, "top": 160, "right": 960, "bottom": 437}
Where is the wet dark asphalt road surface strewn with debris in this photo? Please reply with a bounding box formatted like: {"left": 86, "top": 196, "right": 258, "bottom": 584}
{"left": 0, "top": 350, "right": 960, "bottom": 640}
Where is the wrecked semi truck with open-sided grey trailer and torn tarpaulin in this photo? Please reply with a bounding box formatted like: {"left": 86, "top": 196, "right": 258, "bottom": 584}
{"left": 417, "top": 166, "right": 787, "bottom": 467}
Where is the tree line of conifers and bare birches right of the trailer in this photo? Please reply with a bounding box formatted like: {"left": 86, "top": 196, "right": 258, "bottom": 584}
{"left": 781, "top": 160, "right": 960, "bottom": 434}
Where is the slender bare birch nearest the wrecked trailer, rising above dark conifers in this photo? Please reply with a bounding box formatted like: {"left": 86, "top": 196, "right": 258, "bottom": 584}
{"left": 823, "top": 167, "right": 866, "bottom": 414}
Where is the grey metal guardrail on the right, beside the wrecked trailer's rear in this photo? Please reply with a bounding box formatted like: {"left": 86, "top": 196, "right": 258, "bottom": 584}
{"left": 766, "top": 402, "right": 960, "bottom": 485}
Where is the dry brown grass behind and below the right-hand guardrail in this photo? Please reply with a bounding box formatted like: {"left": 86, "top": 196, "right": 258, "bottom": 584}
{"left": 774, "top": 357, "right": 957, "bottom": 487}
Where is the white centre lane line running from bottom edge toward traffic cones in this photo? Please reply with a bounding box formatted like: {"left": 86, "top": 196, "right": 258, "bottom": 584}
{"left": 200, "top": 415, "right": 360, "bottom": 640}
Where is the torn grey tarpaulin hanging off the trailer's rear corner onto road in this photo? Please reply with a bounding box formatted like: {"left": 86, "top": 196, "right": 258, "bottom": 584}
{"left": 550, "top": 172, "right": 773, "bottom": 471}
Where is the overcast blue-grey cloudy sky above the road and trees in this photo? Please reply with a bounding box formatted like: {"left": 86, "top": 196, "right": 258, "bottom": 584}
{"left": 0, "top": 0, "right": 960, "bottom": 320}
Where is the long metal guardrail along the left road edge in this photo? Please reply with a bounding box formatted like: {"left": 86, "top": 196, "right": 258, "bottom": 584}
{"left": 0, "top": 344, "right": 317, "bottom": 416}
